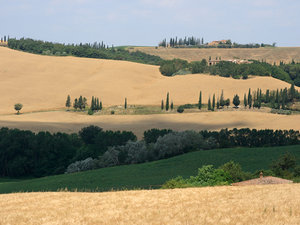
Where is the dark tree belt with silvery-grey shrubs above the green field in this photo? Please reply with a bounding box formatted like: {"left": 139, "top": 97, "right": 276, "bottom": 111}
{"left": 0, "top": 126, "right": 300, "bottom": 177}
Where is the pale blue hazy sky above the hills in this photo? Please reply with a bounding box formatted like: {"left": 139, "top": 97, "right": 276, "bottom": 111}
{"left": 0, "top": 0, "right": 300, "bottom": 46}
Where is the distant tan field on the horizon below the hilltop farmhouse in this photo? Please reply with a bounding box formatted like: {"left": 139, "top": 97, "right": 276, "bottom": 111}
{"left": 134, "top": 47, "right": 300, "bottom": 64}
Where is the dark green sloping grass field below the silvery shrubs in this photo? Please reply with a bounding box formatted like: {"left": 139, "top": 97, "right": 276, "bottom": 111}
{"left": 0, "top": 145, "right": 300, "bottom": 193}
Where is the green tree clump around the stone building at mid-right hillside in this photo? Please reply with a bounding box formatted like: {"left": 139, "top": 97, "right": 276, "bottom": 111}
{"left": 159, "top": 59, "right": 300, "bottom": 87}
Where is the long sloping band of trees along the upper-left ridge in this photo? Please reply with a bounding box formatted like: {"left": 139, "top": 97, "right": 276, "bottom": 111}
{"left": 8, "top": 38, "right": 162, "bottom": 65}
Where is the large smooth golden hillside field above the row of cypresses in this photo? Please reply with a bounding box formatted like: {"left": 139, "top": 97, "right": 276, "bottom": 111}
{"left": 0, "top": 47, "right": 300, "bottom": 114}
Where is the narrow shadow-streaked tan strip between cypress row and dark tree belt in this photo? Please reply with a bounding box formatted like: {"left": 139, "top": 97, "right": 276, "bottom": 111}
{"left": 0, "top": 110, "right": 300, "bottom": 138}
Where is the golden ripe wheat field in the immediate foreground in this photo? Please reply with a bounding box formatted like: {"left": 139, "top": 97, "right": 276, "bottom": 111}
{"left": 0, "top": 184, "right": 300, "bottom": 225}
